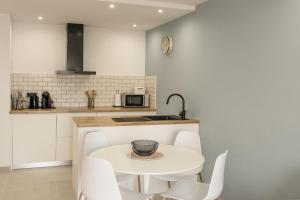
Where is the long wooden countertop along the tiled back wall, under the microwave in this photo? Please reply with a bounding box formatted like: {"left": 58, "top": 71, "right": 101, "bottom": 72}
{"left": 10, "top": 106, "right": 156, "bottom": 114}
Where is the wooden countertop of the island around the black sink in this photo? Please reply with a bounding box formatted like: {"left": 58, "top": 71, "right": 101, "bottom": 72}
{"left": 73, "top": 116, "right": 200, "bottom": 128}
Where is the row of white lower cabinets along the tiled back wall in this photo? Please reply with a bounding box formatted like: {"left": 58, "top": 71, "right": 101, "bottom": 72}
{"left": 12, "top": 112, "right": 156, "bottom": 168}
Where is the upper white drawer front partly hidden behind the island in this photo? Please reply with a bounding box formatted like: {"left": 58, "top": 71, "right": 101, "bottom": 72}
{"left": 57, "top": 113, "right": 96, "bottom": 138}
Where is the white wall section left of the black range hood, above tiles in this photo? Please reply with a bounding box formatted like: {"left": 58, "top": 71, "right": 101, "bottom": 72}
{"left": 12, "top": 23, "right": 67, "bottom": 73}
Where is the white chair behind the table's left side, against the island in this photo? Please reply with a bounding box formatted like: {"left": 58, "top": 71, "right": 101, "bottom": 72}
{"left": 83, "top": 131, "right": 137, "bottom": 190}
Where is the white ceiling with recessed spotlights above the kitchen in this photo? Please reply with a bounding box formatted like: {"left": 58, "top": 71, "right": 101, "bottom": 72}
{"left": 0, "top": 0, "right": 207, "bottom": 30}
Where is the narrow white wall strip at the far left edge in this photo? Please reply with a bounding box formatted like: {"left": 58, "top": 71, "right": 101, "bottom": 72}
{"left": 0, "top": 14, "right": 11, "bottom": 167}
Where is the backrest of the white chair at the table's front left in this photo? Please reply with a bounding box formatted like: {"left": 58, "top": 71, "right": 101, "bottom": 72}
{"left": 81, "top": 156, "right": 122, "bottom": 200}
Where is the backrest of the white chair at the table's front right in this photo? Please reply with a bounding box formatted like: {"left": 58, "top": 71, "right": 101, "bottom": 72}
{"left": 204, "top": 150, "right": 228, "bottom": 200}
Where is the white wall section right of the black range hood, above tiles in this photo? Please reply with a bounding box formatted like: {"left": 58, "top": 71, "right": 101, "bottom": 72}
{"left": 84, "top": 27, "right": 145, "bottom": 75}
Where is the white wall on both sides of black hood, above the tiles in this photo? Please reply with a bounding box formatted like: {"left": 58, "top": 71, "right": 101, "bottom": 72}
{"left": 13, "top": 22, "right": 145, "bottom": 75}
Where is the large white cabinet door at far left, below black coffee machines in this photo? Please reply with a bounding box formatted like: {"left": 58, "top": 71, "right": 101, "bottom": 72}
{"left": 13, "top": 114, "right": 56, "bottom": 165}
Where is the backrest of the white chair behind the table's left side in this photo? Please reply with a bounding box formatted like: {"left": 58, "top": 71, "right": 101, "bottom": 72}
{"left": 83, "top": 131, "right": 108, "bottom": 156}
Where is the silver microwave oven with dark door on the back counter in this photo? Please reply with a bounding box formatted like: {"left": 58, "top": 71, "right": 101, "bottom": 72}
{"left": 121, "top": 94, "right": 150, "bottom": 108}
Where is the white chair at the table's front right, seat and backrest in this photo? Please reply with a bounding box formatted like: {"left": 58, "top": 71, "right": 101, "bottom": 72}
{"left": 161, "top": 151, "right": 228, "bottom": 200}
